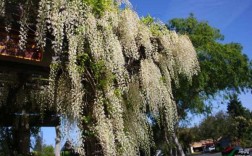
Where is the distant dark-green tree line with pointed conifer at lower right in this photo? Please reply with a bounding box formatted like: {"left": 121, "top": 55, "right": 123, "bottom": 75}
{"left": 179, "top": 94, "right": 252, "bottom": 151}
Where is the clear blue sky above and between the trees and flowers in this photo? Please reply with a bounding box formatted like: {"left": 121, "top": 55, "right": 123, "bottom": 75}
{"left": 43, "top": 0, "right": 252, "bottom": 145}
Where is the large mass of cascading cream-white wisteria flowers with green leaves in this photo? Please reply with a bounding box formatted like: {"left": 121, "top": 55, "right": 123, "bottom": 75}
{"left": 0, "top": 0, "right": 199, "bottom": 156}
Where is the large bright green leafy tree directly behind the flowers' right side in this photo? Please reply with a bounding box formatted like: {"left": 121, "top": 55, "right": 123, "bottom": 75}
{"left": 167, "top": 14, "right": 252, "bottom": 118}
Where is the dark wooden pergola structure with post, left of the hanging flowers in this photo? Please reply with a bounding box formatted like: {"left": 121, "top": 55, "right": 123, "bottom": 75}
{"left": 0, "top": 20, "right": 60, "bottom": 155}
